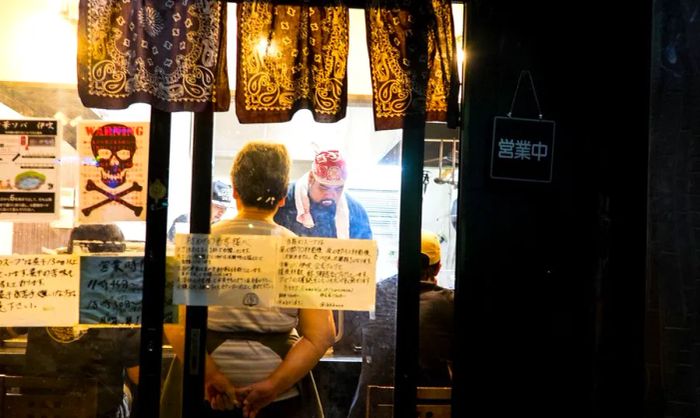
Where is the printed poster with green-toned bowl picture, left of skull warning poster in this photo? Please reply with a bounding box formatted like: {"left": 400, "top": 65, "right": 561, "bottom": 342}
{"left": 0, "top": 119, "right": 61, "bottom": 222}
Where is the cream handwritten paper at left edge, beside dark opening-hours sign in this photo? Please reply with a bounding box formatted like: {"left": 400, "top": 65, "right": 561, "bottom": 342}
{"left": 0, "top": 254, "right": 80, "bottom": 327}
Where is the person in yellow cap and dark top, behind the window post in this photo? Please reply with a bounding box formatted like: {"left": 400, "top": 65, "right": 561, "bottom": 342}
{"left": 348, "top": 230, "right": 454, "bottom": 418}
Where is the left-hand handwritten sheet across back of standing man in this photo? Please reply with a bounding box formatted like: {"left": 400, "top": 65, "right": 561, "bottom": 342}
{"left": 173, "top": 234, "right": 277, "bottom": 307}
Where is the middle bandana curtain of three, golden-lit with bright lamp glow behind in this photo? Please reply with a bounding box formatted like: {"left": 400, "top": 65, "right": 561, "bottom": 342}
{"left": 236, "top": 0, "right": 348, "bottom": 123}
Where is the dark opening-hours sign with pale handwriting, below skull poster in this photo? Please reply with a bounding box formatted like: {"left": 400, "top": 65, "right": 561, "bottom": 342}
{"left": 80, "top": 255, "right": 177, "bottom": 325}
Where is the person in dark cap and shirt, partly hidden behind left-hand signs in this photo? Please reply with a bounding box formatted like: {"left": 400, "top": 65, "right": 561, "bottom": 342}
{"left": 25, "top": 225, "right": 140, "bottom": 418}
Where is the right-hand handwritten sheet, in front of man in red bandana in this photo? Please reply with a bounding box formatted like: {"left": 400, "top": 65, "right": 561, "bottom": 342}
{"left": 276, "top": 237, "right": 377, "bottom": 311}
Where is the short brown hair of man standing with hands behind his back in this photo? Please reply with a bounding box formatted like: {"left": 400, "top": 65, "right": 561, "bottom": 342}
{"left": 231, "top": 142, "right": 290, "bottom": 210}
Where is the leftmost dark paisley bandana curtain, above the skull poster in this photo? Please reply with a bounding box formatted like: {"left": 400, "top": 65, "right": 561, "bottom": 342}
{"left": 78, "top": 0, "right": 231, "bottom": 112}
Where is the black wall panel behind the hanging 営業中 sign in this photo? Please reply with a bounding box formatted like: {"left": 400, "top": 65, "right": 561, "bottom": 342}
{"left": 453, "top": 0, "right": 651, "bottom": 417}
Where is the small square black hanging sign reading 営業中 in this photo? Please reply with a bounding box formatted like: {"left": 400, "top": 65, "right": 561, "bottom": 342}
{"left": 491, "top": 116, "right": 555, "bottom": 183}
